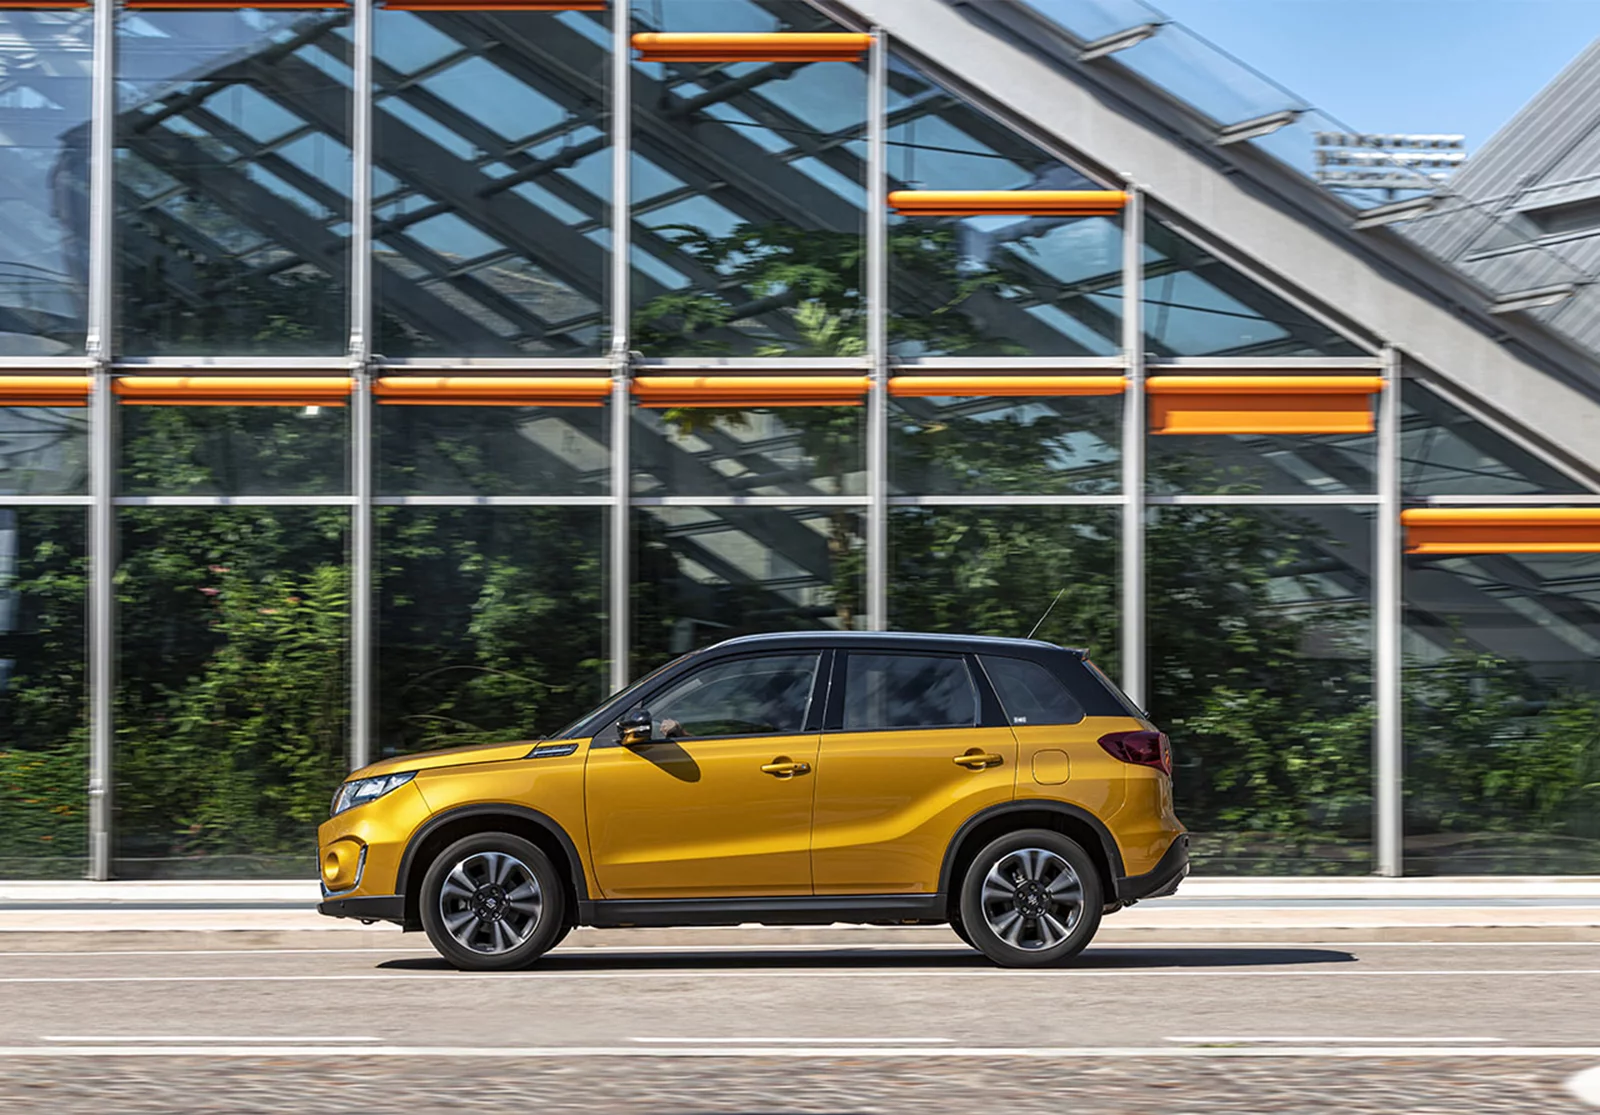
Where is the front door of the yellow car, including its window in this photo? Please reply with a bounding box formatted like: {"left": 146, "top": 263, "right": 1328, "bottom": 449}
{"left": 584, "top": 649, "right": 829, "bottom": 899}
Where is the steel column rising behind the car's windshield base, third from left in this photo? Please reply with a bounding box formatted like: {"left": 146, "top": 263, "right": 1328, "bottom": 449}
{"left": 608, "top": 5, "right": 634, "bottom": 689}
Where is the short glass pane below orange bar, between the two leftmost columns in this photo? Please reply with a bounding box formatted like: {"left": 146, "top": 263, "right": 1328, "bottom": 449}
{"left": 117, "top": 406, "right": 350, "bottom": 496}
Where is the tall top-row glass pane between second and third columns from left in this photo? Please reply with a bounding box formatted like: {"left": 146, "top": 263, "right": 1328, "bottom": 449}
{"left": 373, "top": 8, "right": 611, "bottom": 357}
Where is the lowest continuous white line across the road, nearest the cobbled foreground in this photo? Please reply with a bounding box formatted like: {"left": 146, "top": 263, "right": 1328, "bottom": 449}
{"left": 0, "top": 1045, "right": 1600, "bottom": 1061}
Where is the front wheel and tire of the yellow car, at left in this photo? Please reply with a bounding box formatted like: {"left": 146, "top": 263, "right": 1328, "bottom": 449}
{"left": 419, "top": 832, "right": 568, "bottom": 971}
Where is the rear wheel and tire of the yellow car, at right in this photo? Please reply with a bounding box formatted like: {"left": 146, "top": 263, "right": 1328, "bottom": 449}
{"left": 962, "top": 829, "right": 1104, "bottom": 968}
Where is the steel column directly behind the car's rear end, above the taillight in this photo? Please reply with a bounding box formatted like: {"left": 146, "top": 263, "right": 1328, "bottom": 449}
{"left": 1122, "top": 182, "right": 1147, "bottom": 709}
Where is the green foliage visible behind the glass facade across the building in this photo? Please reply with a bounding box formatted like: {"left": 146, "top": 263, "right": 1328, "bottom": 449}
{"left": 0, "top": 214, "right": 1600, "bottom": 875}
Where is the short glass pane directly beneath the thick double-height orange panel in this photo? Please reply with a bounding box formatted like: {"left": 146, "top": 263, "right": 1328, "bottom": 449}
{"left": 1146, "top": 434, "right": 1378, "bottom": 496}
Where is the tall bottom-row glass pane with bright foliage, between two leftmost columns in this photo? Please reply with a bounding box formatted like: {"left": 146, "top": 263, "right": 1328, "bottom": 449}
{"left": 114, "top": 507, "right": 350, "bottom": 878}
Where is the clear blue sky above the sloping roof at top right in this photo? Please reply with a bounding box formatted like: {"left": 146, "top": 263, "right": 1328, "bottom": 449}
{"left": 1152, "top": 0, "right": 1600, "bottom": 152}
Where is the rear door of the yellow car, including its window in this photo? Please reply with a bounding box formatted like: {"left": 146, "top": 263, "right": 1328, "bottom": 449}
{"left": 811, "top": 651, "right": 1016, "bottom": 894}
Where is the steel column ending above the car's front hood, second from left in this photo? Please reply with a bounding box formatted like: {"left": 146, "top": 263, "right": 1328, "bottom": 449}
{"left": 349, "top": 0, "right": 374, "bottom": 769}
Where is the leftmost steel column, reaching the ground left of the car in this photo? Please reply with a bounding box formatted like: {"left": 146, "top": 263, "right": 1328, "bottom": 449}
{"left": 86, "top": 0, "right": 117, "bottom": 880}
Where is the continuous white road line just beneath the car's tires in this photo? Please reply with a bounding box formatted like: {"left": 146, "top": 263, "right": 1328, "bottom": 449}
{"left": 0, "top": 966, "right": 1600, "bottom": 984}
